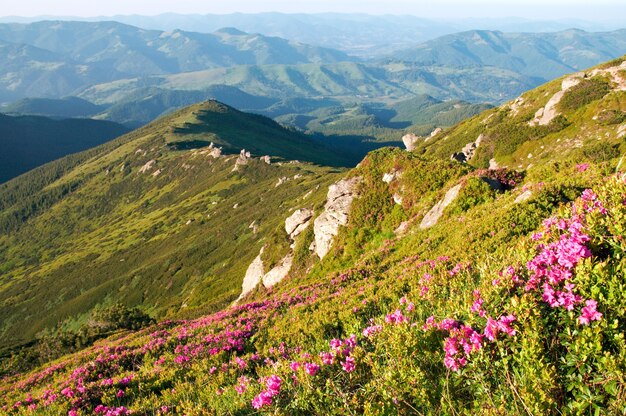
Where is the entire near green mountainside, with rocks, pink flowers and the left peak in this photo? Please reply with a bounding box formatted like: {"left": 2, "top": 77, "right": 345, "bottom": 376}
{"left": 0, "top": 59, "right": 626, "bottom": 416}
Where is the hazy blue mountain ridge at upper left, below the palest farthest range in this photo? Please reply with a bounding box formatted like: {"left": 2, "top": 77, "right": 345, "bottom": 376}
{"left": 0, "top": 21, "right": 353, "bottom": 102}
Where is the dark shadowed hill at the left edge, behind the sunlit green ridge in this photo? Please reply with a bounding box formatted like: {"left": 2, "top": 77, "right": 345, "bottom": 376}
{"left": 0, "top": 114, "right": 128, "bottom": 183}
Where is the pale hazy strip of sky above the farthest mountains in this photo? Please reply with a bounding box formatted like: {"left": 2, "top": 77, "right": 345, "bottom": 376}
{"left": 0, "top": 0, "right": 626, "bottom": 20}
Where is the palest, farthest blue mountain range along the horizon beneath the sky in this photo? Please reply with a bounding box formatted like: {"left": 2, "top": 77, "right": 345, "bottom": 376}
{"left": 0, "top": 13, "right": 622, "bottom": 58}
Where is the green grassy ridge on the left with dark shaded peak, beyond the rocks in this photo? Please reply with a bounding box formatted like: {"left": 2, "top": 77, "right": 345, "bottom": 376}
{"left": 0, "top": 102, "right": 346, "bottom": 343}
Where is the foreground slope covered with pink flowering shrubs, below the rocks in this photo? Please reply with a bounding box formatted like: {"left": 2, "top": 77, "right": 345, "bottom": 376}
{"left": 0, "top": 152, "right": 626, "bottom": 415}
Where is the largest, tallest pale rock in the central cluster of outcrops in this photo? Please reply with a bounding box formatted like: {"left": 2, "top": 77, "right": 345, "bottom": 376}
{"left": 313, "top": 177, "right": 361, "bottom": 259}
